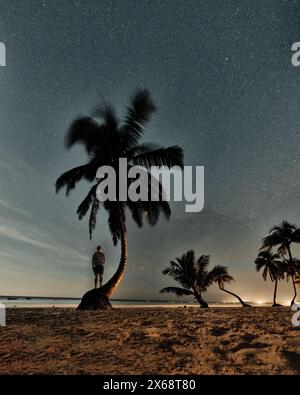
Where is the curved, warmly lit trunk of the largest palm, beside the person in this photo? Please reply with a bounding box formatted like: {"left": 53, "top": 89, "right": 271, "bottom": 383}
{"left": 77, "top": 215, "right": 127, "bottom": 310}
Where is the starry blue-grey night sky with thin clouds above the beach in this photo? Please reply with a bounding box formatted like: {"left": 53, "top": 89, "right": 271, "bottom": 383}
{"left": 0, "top": 0, "right": 300, "bottom": 300}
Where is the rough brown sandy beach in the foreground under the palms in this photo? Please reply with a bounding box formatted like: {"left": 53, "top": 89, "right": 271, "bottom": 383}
{"left": 0, "top": 307, "right": 300, "bottom": 374}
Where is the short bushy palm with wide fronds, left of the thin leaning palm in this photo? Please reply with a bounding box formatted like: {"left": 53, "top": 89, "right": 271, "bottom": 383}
{"left": 160, "top": 250, "right": 233, "bottom": 308}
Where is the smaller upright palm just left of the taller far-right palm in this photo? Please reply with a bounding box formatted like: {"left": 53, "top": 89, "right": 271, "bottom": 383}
{"left": 255, "top": 250, "right": 285, "bottom": 307}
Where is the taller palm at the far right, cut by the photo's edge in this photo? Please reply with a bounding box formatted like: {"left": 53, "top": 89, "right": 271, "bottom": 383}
{"left": 261, "top": 221, "right": 300, "bottom": 305}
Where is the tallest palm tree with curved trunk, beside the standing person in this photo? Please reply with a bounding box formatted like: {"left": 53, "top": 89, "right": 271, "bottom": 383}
{"left": 56, "top": 90, "right": 183, "bottom": 309}
